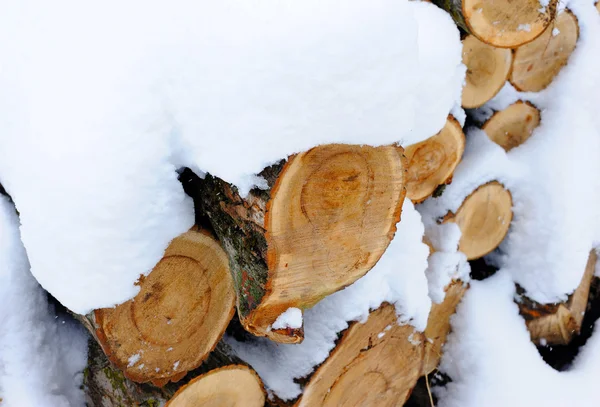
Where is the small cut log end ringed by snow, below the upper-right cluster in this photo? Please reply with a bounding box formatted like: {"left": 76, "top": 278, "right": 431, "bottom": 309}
{"left": 482, "top": 101, "right": 540, "bottom": 151}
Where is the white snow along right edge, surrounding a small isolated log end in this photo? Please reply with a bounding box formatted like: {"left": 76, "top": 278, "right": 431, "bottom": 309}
{"left": 419, "top": 0, "right": 600, "bottom": 303}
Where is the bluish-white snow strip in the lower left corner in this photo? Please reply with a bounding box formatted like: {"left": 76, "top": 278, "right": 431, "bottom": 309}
{"left": 0, "top": 196, "right": 87, "bottom": 407}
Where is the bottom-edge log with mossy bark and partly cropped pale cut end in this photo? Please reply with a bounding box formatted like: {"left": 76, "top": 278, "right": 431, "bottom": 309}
{"left": 83, "top": 340, "right": 265, "bottom": 407}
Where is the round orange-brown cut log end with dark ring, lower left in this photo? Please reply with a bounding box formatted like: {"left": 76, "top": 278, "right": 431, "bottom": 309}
{"left": 94, "top": 230, "right": 235, "bottom": 386}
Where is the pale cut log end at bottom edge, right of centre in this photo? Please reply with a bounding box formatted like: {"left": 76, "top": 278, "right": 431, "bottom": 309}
{"left": 297, "top": 304, "right": 424, "bottom": 407}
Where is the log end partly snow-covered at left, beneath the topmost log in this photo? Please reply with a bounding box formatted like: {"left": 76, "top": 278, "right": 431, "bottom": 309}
{"left": 461, "top": 35, "right": 513, "bottom": 109}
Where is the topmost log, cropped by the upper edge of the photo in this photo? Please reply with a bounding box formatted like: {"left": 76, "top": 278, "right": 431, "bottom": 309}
{"left": 433, "top": 0, "right": 558, "bottom": 48}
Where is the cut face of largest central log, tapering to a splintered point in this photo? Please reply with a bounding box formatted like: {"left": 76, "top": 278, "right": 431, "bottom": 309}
{"left": 242, "top": 144, "right": 406, "bottom": 343}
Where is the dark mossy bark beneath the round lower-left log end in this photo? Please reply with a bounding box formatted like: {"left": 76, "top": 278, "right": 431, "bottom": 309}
{"left": 83, "top": 339, "right": 245, "bottom": 407}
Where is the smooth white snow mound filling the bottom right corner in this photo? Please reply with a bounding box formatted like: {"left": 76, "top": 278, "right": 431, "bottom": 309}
{"left": 434, "top": 272, "right": 600, "bottom": 407}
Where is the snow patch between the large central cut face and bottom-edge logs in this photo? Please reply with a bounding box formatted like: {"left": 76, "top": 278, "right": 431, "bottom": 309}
{"left": 226, "top": 199, "right": 431, "bottom": 400}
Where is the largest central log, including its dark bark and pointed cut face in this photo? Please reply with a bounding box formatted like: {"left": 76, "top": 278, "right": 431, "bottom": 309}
{"left": 192, "top": 144, "right": 406, "bottom": 343}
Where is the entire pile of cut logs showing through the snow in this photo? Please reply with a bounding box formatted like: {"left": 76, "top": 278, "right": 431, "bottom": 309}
{"left": 70, "top": 0, "right": 596, "bottom": 407}
